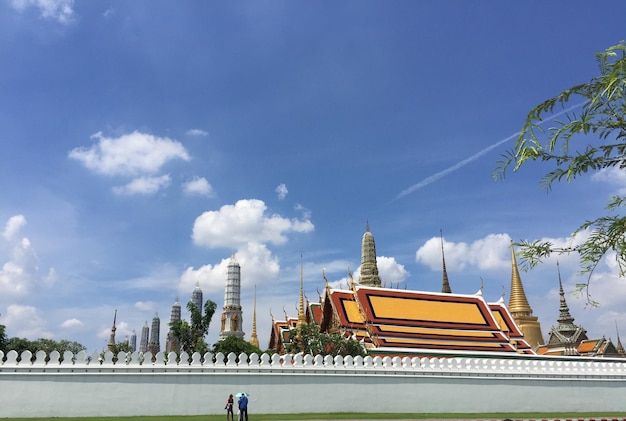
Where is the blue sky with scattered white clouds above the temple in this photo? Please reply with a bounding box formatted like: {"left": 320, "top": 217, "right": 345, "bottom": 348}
{"left": 0, "top": 0, "right": 626, "bottom": 352}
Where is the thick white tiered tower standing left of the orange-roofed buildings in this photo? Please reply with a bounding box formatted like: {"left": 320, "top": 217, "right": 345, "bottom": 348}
{"left": 219, "top": 254, "right": 244, "bottom": 339}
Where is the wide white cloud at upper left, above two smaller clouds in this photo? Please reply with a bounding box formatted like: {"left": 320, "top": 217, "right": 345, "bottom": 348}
{"left": 68, "top": 131, "right": 190, "bottom": 176}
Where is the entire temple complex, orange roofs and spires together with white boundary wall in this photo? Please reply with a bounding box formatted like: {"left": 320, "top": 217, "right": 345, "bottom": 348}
{"left": 0, "top": 229, "right": 626, "bottom": 418}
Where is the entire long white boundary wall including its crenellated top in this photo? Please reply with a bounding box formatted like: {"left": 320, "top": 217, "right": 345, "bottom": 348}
{"left": 0, "top": 351, "right": 626, "bottom": 418}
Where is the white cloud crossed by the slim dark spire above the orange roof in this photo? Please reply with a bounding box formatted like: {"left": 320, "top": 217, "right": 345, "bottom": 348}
{"left": 415, "top": 234, "right": 511, "bottom": 272}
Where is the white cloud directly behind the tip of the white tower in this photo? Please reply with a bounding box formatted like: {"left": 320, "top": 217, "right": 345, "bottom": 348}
{"left": 178, "top": 243, "right": 280, "bottom": 294}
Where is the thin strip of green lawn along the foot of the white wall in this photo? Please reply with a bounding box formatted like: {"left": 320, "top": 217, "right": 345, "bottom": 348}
{"left": 0, "top": 412, "right": 626, "bottom": 421}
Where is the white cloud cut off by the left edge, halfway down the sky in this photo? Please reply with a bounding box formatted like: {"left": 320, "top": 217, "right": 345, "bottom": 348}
{"left": 0, "top": 215, "right": 56, "bottom": 296}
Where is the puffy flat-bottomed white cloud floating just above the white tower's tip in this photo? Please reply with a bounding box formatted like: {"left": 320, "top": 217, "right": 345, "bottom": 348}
{"left": 192, "top": 199, "right": 314, "bottom": 249}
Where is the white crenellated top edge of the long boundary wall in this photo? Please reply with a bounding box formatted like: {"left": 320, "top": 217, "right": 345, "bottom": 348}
{"left": 0, "top": 351, "right": 626, "bottom": 380}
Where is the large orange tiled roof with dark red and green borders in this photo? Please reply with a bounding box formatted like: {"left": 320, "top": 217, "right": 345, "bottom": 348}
{"left": 322, "top": 287, "right": 534, "bottom": 354}
